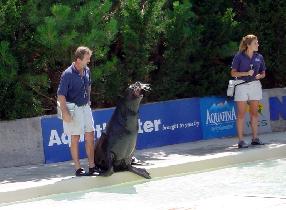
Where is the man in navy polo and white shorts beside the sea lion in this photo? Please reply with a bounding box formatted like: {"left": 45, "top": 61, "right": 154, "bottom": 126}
{"left": 57, "top": 46, "right": 99, "bottom": 176}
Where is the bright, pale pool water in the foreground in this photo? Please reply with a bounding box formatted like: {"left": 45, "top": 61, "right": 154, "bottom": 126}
{"left": 0, "top": 159, "right": 286, "bottom": 210}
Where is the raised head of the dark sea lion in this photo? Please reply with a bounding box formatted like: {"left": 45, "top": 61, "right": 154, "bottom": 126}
{"left": 125, "top": 82, "right": 151, "bottom": 112}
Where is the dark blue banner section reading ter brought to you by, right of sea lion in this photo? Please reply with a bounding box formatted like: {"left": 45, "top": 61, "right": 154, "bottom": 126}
{"left": 137, "top": 98, "right": 202, "bottom": 149}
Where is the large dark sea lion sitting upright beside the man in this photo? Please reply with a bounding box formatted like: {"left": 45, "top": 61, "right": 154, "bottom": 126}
{"left": 94, "top": 82, "right": 151, "bottom": 179}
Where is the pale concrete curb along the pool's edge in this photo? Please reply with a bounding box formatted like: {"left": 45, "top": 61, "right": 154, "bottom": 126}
{"left": 0, "top": 144, "right": 286, "bottom": 205}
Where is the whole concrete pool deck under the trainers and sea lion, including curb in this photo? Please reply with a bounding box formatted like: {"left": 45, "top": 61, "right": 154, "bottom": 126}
{"left": 0, "top": 132, "right": 286, "bottom": 206}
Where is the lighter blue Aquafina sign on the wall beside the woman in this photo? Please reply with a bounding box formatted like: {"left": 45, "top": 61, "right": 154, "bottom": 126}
{"left": 200, "top": 97, "right": 236, "bottom": 139}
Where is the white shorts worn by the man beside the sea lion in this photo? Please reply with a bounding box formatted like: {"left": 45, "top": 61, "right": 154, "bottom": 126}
{"left": 63, "top": 105, "right": 94, "bottom": 135}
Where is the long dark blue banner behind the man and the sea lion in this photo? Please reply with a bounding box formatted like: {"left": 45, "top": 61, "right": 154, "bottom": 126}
{"left": 41, "top": 98, "right": 202, "bottom": 163}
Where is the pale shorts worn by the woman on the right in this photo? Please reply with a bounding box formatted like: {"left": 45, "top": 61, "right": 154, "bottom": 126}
{"left": 234, "top": 80, "right": 262, "bottom": 101}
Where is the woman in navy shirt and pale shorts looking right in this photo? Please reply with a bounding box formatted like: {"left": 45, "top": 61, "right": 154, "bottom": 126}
{"left": 231, "top": 34, "right": 266, "bottom": 148}
